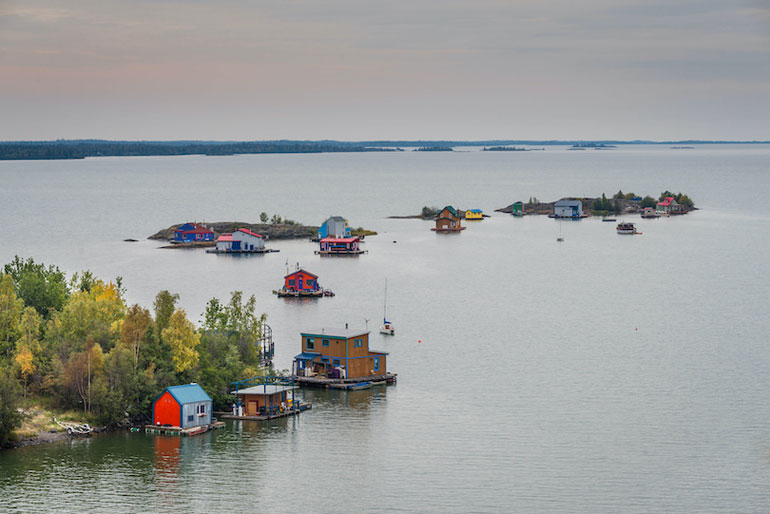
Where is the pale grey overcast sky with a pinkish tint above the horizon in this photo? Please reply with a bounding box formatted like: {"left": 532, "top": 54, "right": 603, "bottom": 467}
{"left": 0, "top": 0, "right": 770, "bottom": 141}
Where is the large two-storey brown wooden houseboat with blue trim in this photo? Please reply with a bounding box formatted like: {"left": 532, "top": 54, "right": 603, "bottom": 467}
{"left": 293, "top": 328, "right": 396, "bottom": 388}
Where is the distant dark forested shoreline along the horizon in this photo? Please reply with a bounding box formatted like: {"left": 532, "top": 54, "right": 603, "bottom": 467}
{"left": 0, "top": 139, "right": 770, "bottom": 160}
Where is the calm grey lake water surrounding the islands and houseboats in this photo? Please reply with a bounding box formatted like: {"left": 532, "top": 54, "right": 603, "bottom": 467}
{"left": 0, "top": 145, "right": 770, "bottom": 513}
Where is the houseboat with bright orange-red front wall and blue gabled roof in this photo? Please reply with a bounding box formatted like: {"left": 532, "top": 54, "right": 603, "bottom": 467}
{"left": 145, "top": 384, "right": 224, "bottom": 435}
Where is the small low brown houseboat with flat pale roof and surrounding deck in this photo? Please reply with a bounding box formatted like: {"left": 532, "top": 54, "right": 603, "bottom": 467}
{"left": 220, "top": 376, "right": 312, "bottom": 421}
